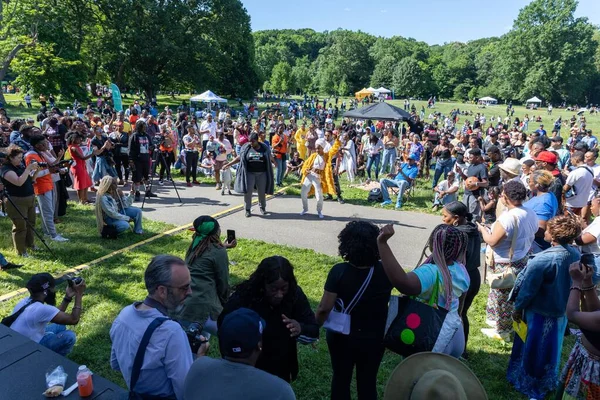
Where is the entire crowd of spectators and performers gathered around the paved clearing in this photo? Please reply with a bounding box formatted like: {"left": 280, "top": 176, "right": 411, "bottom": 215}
{"left": 0, "top": 94, "right": 600, "bottom": 399}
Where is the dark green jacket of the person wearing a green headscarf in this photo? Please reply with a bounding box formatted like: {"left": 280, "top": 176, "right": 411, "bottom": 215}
{"left": 176, "top": 244, "right": 229, "bottom": 324}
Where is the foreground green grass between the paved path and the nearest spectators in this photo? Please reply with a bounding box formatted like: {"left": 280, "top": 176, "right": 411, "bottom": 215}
{"left": 0, "top": 223, "right": 573, "bottom": 400}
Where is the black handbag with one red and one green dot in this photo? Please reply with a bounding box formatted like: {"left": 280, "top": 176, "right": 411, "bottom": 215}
{"left": 383, "top": 275, "right": 448, "bottom": 357}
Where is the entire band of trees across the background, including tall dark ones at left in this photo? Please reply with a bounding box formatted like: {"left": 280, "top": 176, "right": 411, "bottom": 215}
{"left": 0, "top": 0, "right": 600, "bottom": 104}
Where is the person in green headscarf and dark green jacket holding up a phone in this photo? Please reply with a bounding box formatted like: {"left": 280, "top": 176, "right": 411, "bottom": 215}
{"left": 174, "top": 215, "right": 237, "bottom": 336}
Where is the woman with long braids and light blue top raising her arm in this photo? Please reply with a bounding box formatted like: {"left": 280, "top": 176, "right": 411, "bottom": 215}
{"left": 377, "top": 224, "right": 470, "bottom": 358}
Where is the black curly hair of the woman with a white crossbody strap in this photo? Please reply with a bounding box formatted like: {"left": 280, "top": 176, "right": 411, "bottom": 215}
{"left": 338, "top": 221, "right": 379, "bottom": 267}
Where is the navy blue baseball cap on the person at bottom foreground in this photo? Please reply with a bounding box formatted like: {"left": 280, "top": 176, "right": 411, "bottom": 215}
{"left": 219, "top": 308, "right": 267, "bottom": 358}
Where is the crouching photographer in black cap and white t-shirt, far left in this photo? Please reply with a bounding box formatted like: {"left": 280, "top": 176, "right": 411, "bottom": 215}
{"left": 2, "top": 273, "right": 85, "bottom": 356}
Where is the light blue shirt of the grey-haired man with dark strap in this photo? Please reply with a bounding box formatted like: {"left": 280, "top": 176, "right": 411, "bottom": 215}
{"left": 110, "top": 303, "right": 193, "bottom": 399}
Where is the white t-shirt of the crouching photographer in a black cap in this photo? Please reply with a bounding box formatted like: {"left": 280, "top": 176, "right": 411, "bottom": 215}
{"left": 10, "top": 297, "right": 60, "bottom": 343}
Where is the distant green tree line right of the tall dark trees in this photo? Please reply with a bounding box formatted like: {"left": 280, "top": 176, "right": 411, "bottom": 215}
{"left": 254, "top": 0, "right": 600, "bottom": 104}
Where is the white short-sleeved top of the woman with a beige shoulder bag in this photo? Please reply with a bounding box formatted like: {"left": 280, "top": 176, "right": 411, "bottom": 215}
{"left": 492, "top": 207, "right": 538, "bottom": 263}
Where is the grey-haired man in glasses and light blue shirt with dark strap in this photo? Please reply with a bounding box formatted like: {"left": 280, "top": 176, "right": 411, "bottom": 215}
{"left": 110, "top": 255, "right": 209, "bottom": 399}
